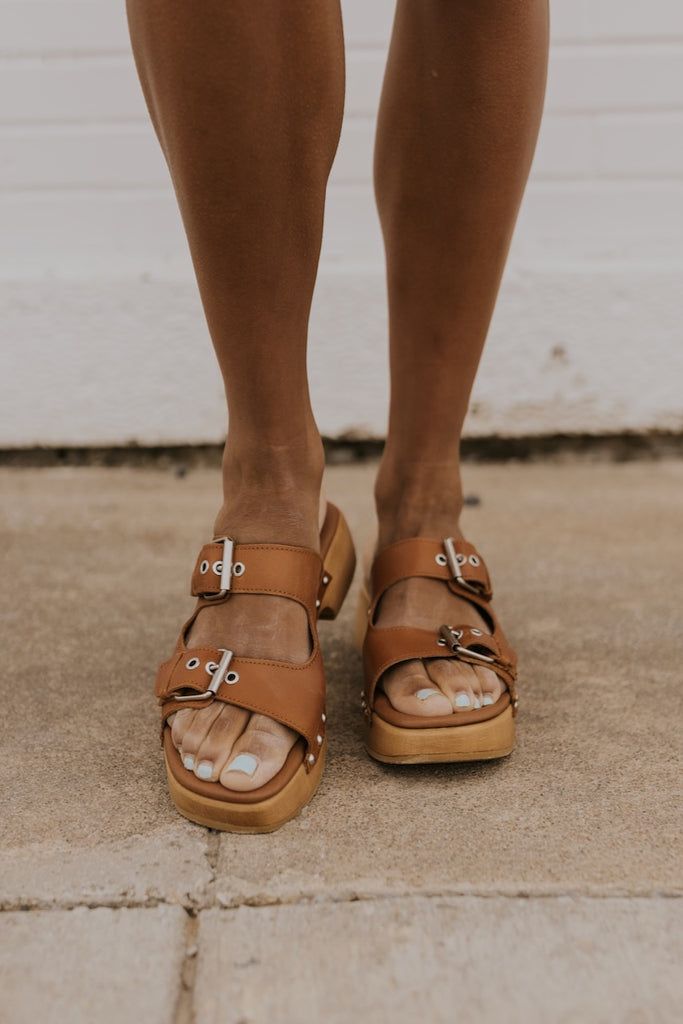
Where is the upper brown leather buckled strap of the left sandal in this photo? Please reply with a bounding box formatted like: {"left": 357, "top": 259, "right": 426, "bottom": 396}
{"left": 191, "top": 541, "right": 323, "bottom": 610}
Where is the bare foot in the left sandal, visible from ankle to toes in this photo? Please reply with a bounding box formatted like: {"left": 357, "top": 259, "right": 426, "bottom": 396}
{"left": 170, "top": 440, "right": 323, "bottom": 792}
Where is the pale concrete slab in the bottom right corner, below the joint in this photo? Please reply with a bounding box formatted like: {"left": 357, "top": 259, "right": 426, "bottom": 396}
{"left": 196, "top": 897, "right": 683, "bottom": 1024}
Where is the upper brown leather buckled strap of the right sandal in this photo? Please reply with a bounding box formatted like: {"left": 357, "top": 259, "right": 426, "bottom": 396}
{"left": 370, "top": 537, "right": 493, "bottom": 601}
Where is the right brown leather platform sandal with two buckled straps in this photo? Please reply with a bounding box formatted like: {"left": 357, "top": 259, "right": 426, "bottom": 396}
{"left": 359, "top": 538, "right": 518, "bottom": 764}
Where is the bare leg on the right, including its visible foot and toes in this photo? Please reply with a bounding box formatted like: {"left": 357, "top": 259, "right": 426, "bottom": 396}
{"left": 375, "top": 0, "right": 548, "bottom": 715}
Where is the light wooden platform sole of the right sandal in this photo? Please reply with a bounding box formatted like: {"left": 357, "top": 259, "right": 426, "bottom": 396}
{"left": 366, "top": 705, "right": 515, "bottom": 765}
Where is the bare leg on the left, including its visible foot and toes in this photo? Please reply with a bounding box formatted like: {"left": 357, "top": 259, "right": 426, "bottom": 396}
{"left": 128, "top": 0, "right": 344, "bottom": 790}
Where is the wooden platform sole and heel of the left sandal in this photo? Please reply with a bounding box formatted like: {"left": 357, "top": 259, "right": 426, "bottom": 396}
{"left": 164, "top": 506, "right": 355, "bottom": 833}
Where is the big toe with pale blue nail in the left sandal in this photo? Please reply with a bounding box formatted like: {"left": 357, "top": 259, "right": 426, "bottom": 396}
{"left": 220, "top": 715, "right": 297, "bottom": 792}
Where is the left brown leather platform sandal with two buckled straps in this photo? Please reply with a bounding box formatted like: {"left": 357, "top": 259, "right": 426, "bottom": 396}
{"left": 155, "top": 503, "right": 355, "bottom": 833}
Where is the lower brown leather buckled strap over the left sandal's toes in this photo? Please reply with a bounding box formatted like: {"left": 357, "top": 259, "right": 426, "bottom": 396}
{"left": 155, "top": 647, "right": 326, "bottom": 765}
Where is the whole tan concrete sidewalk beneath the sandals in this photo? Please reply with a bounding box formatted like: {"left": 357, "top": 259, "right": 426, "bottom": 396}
{"left": 0, "top": 462, "right": 683, "bottom": 1024}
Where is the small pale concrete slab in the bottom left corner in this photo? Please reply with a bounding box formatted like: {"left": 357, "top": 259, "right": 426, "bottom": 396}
{"left": 0, "top": 906, "right": 187, "bottom": 1024}
